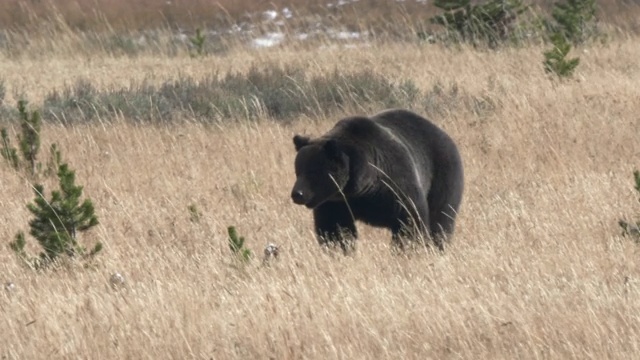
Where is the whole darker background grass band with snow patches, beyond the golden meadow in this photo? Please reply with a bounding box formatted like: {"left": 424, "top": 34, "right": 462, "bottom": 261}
{"left": 0, "top": 0, "right": 640, "bottom": 58}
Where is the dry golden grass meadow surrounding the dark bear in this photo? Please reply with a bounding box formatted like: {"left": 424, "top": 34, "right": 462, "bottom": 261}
{"left": 0, "top": 0, "right": 640, "bottom": 359}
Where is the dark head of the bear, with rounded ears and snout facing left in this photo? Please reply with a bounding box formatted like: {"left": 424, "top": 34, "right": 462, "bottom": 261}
{"left": 291, "top": 135, "right": 349, "bottom": 209}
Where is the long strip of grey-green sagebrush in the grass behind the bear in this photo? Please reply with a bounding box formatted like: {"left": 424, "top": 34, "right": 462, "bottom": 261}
{"left": 44, "top": 65, "right": 419, "bottom": 123}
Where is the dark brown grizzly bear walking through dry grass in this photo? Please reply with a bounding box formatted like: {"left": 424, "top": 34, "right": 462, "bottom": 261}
{"left": 291, "top": 109, "right": 464, "bottom": 252}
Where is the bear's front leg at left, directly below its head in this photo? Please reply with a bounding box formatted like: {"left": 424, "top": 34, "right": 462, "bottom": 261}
{"left": 313, "top": 201, "right": 358, "bottom": 254}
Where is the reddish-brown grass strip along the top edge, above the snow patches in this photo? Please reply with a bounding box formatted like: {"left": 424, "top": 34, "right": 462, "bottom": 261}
{"left": 0, "top": 0, "right": 638, "bottom": 31}
